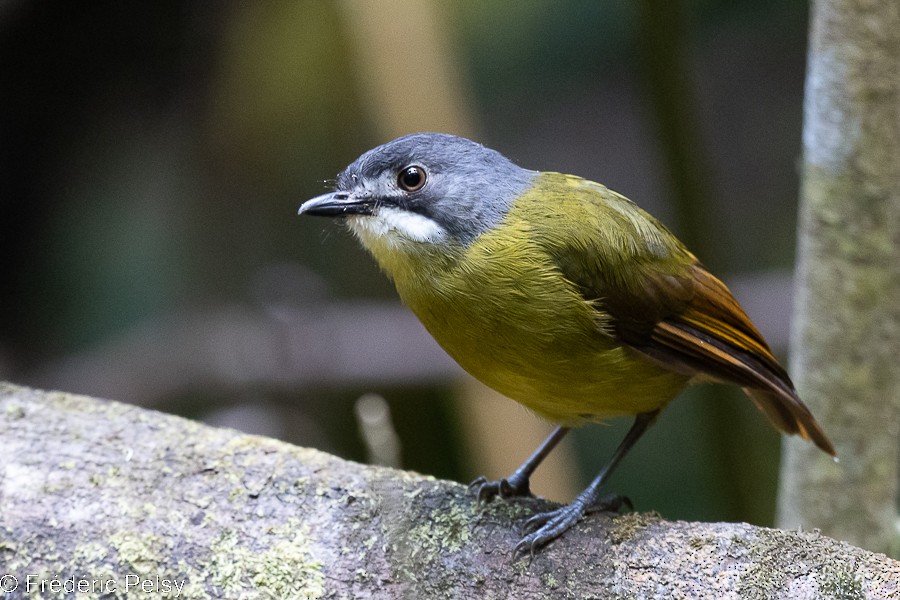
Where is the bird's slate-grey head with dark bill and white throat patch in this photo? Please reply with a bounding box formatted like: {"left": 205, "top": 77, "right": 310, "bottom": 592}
{"left": 299, "top": 133, "right": 537, "bottom": 245}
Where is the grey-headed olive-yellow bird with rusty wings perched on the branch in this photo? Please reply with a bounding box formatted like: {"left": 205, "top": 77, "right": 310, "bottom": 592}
{"left": 298, "top": 133, "right": 835, "bottom": 555}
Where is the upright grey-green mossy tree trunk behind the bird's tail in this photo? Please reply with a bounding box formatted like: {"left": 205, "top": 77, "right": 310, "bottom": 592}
{"left": 779, "top": 0, "right": 900, "bottom": 556}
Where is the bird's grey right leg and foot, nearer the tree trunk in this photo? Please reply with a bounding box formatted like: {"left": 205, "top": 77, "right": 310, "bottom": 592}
{"left": 515, "top": 410, "right": 659, "bottom": 555}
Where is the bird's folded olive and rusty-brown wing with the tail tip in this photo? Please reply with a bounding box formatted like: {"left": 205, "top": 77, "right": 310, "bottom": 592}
{"left": 554, "top": 180, "right": 835, "bottom": 455}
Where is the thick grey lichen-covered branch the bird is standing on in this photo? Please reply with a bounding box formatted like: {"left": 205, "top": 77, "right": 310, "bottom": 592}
{"left": 0, "top": 384, "right": 900, "bottom": 598}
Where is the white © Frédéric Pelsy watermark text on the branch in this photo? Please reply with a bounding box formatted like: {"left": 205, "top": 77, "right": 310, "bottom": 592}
{"left": 0, "top": 573, "right": 187, "bottom": 598}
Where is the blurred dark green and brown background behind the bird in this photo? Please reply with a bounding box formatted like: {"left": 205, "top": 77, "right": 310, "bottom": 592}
{"left": 0, "top": 0, "right": 807, "bottom": 524}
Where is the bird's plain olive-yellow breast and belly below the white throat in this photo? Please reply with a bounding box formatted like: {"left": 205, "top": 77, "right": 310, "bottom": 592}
{"left": 394, "top": 236, "right": 689, "bottom": 425}
